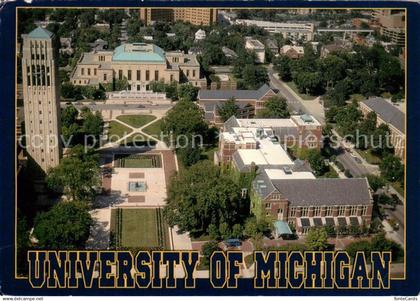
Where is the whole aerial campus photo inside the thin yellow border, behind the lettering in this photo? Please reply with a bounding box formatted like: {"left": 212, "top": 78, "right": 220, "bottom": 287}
{"left": 15, "top": 7, "right": 406, "bottom": 279}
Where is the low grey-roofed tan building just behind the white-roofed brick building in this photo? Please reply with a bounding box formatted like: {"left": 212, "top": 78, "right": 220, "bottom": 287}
{"left": 198, "top": 85, "right": 276, "bottom": 125}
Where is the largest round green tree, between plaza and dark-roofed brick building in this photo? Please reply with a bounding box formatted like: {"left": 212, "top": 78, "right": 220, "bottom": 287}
{"left": 164, "top": 161, "right": 249, "bottom": 237}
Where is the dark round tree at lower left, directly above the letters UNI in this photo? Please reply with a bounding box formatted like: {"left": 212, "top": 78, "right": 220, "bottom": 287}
{"left": 33, "top": 202, "right": 93, "bottom": 250}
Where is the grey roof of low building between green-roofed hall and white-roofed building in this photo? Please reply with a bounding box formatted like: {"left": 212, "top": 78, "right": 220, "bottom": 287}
{"left": 198, "top": 84, "right": 271, "bottom": 100}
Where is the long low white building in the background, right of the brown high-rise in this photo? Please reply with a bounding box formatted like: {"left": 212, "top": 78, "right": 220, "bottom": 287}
{"left": 235, "top": 19, "right": 315, "bottom": 41}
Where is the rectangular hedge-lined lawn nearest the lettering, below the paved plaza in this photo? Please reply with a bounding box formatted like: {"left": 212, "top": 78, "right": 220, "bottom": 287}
{"left": 111, "top": 208, "right": 170, "bottom": 250}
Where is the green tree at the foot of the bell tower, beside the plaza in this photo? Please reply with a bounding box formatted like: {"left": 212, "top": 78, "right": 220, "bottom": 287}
{"left": 46, "top": 147, "right": 101, "bottom": 202}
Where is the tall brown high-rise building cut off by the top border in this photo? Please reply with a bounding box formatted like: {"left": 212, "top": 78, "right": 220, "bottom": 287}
{"left": 139, "top": 8, "right": 217, "bottom": 26}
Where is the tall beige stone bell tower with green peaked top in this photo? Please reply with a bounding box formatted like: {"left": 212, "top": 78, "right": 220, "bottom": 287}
{"left": 22, "top": 27, "right": 61, "bottom": 172}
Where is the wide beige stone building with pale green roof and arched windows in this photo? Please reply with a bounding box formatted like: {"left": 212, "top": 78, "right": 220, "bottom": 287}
{"left": 70, "top": 43, "right": 206, "bottom": 91}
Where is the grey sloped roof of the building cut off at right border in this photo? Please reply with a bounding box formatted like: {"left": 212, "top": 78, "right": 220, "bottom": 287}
{"left": 363, "top": 97, "right": 405, "bottom": 133}
